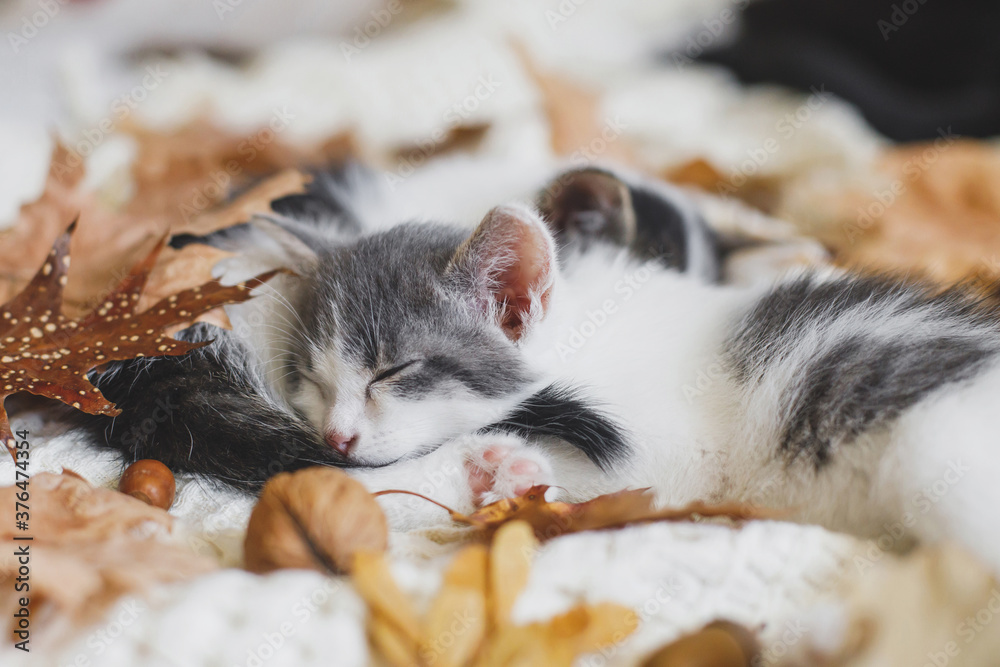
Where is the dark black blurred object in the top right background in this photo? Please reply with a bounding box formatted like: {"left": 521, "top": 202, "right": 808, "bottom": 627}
{"left": 700, "top": 0, "right": 1000, "bottom": 141}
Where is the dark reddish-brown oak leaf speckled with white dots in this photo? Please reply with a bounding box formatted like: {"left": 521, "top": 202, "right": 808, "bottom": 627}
{"left": 0, "top": 223, "right": 274, "bottom": 456}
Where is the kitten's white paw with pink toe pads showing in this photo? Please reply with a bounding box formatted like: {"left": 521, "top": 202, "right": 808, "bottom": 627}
{"left": 465, "top": 439, "right": 553, "bottom": 506}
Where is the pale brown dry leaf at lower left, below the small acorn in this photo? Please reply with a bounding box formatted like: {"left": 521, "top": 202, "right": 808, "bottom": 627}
{"left": 0, "top": 471, "right": 218, "bottom": 639}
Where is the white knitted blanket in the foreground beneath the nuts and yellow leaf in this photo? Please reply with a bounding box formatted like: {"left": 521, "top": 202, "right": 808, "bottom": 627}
{"left": 0, "top": 416, "right": 856, "bottom": 667}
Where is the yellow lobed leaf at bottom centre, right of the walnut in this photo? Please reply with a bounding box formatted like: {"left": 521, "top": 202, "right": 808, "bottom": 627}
{"left": 351, "top": 521, "right": 639, "bottom": 667}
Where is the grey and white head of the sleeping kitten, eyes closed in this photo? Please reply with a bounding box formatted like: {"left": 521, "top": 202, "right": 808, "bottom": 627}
{"left": 288, "top": 206, "right": 556, "bottom": 465}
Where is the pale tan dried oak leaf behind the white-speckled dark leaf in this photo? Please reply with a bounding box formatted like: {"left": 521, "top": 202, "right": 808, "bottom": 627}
{"left": 0, "top": 143, "right": 306, "bottom": 318}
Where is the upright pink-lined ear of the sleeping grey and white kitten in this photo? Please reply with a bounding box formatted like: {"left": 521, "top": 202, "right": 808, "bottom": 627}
{"left": 448, "top": 206, "right": 556, "bottom": 341}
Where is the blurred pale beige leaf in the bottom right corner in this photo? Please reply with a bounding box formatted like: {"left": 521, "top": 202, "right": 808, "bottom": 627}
{"left": 783, "top": 542, "right": 1000, "bottom": 667}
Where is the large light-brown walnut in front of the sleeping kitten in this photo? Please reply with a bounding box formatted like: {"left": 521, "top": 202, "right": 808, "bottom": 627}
{"left": 243, "top": 467, "right": 389, "bottom": 573}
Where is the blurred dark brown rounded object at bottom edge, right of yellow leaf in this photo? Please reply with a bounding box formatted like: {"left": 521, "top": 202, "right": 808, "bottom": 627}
{"left": 642, "top": 621, "right": 761, "bottom": 667}
